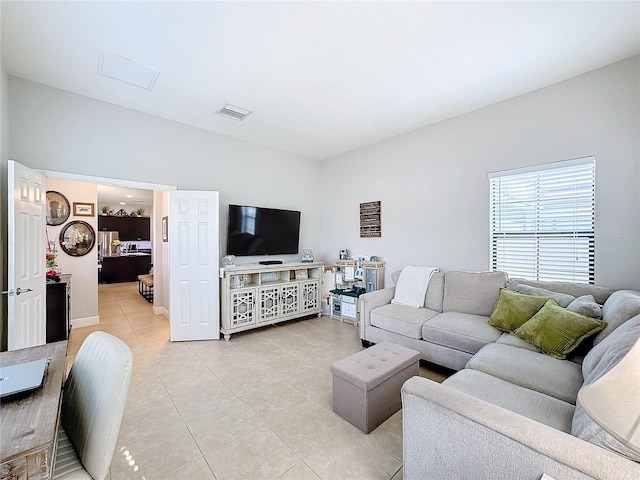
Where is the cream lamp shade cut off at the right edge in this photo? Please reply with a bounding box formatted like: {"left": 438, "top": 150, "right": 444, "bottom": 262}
{"left": 578, "top": 340, "right": 640, "bottom": 453}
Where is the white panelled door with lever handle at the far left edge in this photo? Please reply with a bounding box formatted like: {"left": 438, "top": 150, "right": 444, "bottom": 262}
{"left": 7, "top": 160, "right": 47, "bottom": 350}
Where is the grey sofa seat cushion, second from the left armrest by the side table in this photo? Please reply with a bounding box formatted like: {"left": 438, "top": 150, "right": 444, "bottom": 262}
{"left": 422, "top": 312, "right": 501, "bottom": 354}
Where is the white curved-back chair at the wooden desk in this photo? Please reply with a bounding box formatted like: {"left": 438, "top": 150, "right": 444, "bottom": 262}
{"left": 53, "top": 332, "right": 133, "bottom": 480}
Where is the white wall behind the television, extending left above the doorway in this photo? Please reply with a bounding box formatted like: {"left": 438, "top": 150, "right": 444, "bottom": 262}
{"left": 9, "top": 76, "right": 321, "bottom": 262}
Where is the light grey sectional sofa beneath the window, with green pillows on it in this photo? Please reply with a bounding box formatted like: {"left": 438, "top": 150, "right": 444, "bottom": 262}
{"left": 360, "top": 272, "right": 640, "bottom": 480}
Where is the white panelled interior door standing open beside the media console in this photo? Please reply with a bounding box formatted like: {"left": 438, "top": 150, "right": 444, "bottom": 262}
{"left": 168, "top": 190, "right": 220, "bottom": 341}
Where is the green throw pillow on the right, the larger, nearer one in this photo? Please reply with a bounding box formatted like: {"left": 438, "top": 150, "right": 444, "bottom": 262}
{"left": 513, "top": 300, "right": 607, "bottom": 360}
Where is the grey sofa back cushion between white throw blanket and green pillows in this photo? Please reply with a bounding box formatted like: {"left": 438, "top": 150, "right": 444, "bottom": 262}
{"left": 442, "top": 271, "right": 507, "bottom": 317}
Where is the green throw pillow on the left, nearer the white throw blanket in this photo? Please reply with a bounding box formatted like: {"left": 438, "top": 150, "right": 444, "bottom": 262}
{"left": 489, "top": 288, "right": 555, "bottom": 332}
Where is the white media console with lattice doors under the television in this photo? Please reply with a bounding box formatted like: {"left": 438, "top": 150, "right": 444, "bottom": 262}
{"left": 220, "top": 262, "right": 322, "bottom": 341}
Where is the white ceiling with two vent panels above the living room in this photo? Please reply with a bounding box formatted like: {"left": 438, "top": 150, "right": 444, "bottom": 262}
{"left": 1, "top": 0, "right": 640, "bottom": 159}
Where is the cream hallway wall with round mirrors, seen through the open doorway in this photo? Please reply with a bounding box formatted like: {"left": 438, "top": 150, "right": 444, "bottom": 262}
{"left": 42, "top": 178, "right": 99, "bottom": 327}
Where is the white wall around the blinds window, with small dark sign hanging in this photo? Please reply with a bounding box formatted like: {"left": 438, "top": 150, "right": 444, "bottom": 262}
{"left": 322, "top": 57, "right": 640, "bottom": 289}
